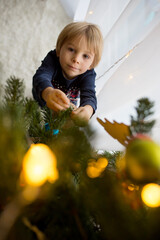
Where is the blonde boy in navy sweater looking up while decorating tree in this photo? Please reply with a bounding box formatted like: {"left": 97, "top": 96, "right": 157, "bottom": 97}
{"left": 32, "top": 22, "right": 103, "bottom": 122}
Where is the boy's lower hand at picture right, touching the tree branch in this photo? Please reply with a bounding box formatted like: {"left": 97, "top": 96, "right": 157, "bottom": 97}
{"left": 71, "top": 105, "right": 93, "bottom": 126}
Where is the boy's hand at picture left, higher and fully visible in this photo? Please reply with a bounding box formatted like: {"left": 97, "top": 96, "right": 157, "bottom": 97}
{"left": 42, "top": 87, "right": 70, "bottom": 112}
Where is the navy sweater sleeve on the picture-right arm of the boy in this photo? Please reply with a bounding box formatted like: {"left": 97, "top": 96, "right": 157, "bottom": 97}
{"left": 80, "top": 69, "right": 97, "bottom": 113}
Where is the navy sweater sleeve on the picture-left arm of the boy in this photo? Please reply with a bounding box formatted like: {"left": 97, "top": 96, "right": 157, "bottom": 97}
{"left": 32, "top": 50, "right": 56, "bottom": 106}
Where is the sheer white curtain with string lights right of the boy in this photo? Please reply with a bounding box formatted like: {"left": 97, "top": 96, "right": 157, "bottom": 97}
{"left": 85, "top": 0, "right": 160, "bottom": 150}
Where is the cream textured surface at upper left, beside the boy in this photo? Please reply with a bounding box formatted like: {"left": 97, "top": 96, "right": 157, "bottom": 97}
{"left": 0, "top": 0, "right": 71, "bottom": 96}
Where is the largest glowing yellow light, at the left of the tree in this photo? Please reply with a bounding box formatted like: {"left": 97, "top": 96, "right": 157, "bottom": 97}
{"left": 23, "top": 143, "right": 58, "bottom": 186}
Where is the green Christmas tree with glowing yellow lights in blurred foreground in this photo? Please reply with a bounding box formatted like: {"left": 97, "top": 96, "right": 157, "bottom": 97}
{"left": 0, "top": 76, "right": 160, "bottom": 240}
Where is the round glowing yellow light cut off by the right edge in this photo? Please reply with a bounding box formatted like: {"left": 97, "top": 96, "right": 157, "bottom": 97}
{"left": 141, "top": 183, "right": 160, "bottom": 207}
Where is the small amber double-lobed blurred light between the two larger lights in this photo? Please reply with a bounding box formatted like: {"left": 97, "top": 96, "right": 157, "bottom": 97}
{"left": 86, "top": 158, "right": 108, "bottom": 178}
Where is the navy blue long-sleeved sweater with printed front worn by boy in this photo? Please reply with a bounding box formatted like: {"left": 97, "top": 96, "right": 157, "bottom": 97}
{"left": 32, "top": 50, "right": 97, "bottom": 112}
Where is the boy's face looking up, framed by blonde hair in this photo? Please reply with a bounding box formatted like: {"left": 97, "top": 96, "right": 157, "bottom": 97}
{"left": 58, "top": 37, "right": 95, "bottom": 79}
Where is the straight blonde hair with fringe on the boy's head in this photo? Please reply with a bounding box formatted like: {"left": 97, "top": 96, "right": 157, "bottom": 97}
{"left": 56, "top": 22, "right": 103, "bottom": 68}
